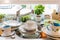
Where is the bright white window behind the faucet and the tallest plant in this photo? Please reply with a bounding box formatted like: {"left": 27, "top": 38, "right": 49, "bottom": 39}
{"left": 0, "top": 4, "right": 58, "bottom": 14}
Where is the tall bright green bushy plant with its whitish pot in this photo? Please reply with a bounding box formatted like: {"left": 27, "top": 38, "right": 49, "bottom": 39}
{"left": 34, "top": 5, "right": 45, "bottom": 21}
